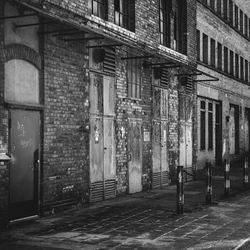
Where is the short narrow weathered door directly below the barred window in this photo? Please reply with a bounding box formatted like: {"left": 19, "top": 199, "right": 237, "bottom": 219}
{"left": 128, "top": 119, "right": 142, "bottom": 193}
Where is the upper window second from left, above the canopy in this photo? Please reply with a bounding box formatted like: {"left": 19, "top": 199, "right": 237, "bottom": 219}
{"left": 115, "top": 0, "right": 135, "bottom": 32}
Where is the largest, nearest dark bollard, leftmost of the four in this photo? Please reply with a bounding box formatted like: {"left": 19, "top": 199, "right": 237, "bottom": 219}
{"left": 176, "top": 166, "right": 184, "bottom": 214}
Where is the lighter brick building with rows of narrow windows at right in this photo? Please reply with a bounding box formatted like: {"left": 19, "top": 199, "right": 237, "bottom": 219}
{"left": 197, "top": 0, "right": 250, "bottom": 168}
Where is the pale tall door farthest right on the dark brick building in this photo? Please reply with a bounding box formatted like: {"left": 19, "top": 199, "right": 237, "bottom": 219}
{"left": 179, "top": 95, "right": 193, "bottom": 179}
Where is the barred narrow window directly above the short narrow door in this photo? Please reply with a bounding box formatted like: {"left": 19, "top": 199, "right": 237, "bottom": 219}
{"left": 127, "top": 56, "right": 141, "bottom": 99}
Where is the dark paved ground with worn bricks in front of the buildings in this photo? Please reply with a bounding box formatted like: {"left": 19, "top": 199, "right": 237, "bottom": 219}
{"left": 0, "top": 168, "right": 250, "bottom": 250}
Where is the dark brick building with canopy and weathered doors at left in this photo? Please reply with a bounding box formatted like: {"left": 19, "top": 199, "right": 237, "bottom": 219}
{"left": 0, "top": 0, "right": 201, "bottom": 227}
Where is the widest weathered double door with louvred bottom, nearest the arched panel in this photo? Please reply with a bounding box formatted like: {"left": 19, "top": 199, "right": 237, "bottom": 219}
{"left": 90, "top": 74, "right": 116, "bottom": 201}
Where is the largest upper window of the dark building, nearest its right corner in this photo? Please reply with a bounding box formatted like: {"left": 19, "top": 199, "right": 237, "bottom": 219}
{"left": 160, "top": 0, "right": 187, "bottom": 54}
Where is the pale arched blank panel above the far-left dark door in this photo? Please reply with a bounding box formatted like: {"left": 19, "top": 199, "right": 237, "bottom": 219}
{"left": 4, "top": 59, "right": 39, "bottom": 104}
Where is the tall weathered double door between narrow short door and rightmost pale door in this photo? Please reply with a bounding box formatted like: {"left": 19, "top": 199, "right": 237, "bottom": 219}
{"left": 152, "top": 87, "right": 169, "bottom": 188}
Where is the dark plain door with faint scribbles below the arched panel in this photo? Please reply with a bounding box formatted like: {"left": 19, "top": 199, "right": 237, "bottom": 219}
{"left": 10, "top": 110, "right": 40, "bottom": 220}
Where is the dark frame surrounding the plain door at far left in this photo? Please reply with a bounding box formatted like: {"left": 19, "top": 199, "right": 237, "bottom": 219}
{"left": 5, "top": 103, "right": 44, "bottom": 222}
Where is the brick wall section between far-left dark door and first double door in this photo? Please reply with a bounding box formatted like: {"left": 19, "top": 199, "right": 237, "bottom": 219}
{"left": 42, "top": 23, "right": 89, "bottom": 211}
